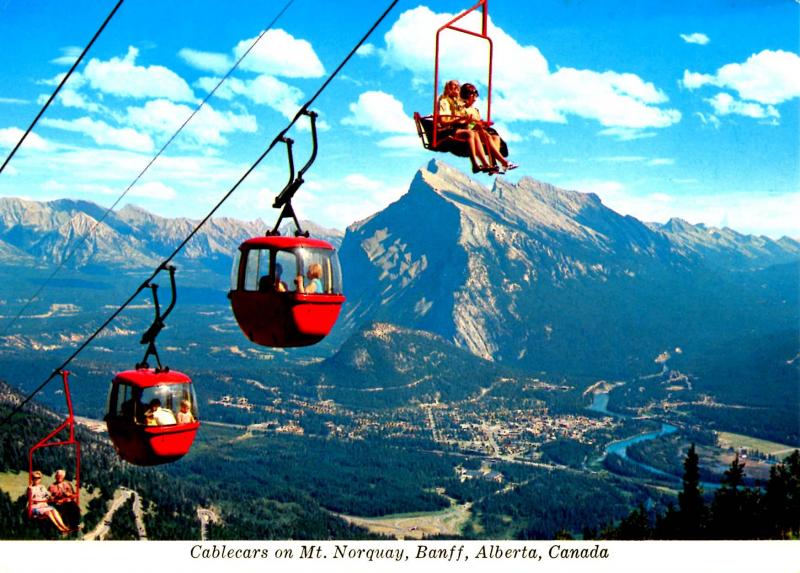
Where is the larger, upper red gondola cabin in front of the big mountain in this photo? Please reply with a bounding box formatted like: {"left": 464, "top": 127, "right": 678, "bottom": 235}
{"left": 228, "top": 235, "right": 345, "bottom": 347}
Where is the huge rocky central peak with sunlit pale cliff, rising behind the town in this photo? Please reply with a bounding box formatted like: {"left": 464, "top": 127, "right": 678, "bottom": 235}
{"left": 341, "top": 161, "right": 797, "bottom": 374}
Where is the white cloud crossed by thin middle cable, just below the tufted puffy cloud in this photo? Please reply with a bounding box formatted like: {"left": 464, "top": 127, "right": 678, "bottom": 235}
{"left": 127, "top": 99, "right": 257, "bottom": 145}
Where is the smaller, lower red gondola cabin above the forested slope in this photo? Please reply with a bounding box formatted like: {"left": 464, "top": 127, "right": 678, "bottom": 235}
{"left": 106, "top": 368, "right": 200, "bottom": 466}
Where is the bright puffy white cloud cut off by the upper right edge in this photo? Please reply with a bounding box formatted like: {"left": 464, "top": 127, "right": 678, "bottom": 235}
{"left": 683, "top": 50, "right": 800, "bottom": 105}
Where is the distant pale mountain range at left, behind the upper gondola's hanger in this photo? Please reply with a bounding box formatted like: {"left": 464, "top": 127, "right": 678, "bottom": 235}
{"left": 0, "top": 198, "right": 342, "bottom": 274}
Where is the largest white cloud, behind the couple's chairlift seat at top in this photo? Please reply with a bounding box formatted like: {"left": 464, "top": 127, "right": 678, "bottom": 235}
{"left": 381, "top": 6, "right": 681, "bottom": 129}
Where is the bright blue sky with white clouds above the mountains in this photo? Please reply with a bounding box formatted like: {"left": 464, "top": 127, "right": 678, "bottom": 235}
{"left": 0, "top": 0, "right": 800, "bottom": 238}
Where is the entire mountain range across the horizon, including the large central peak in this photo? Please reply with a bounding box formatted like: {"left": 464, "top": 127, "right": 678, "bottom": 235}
{"left": 0, "top": 160, "right": 800, "bottom": 422}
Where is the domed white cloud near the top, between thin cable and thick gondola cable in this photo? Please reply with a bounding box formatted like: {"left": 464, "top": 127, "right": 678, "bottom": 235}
{"left": 234, "top": 29, "right": 325, "bottom": 78}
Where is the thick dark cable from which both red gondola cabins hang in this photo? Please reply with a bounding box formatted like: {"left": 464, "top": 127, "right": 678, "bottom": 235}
{"left": 0, "top": 0, "right": 398, "bottom": 426}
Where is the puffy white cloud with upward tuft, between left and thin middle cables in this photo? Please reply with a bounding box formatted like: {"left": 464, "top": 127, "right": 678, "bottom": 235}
{"left": 83, "top": 46, "right": 195, "bottom": 102}
